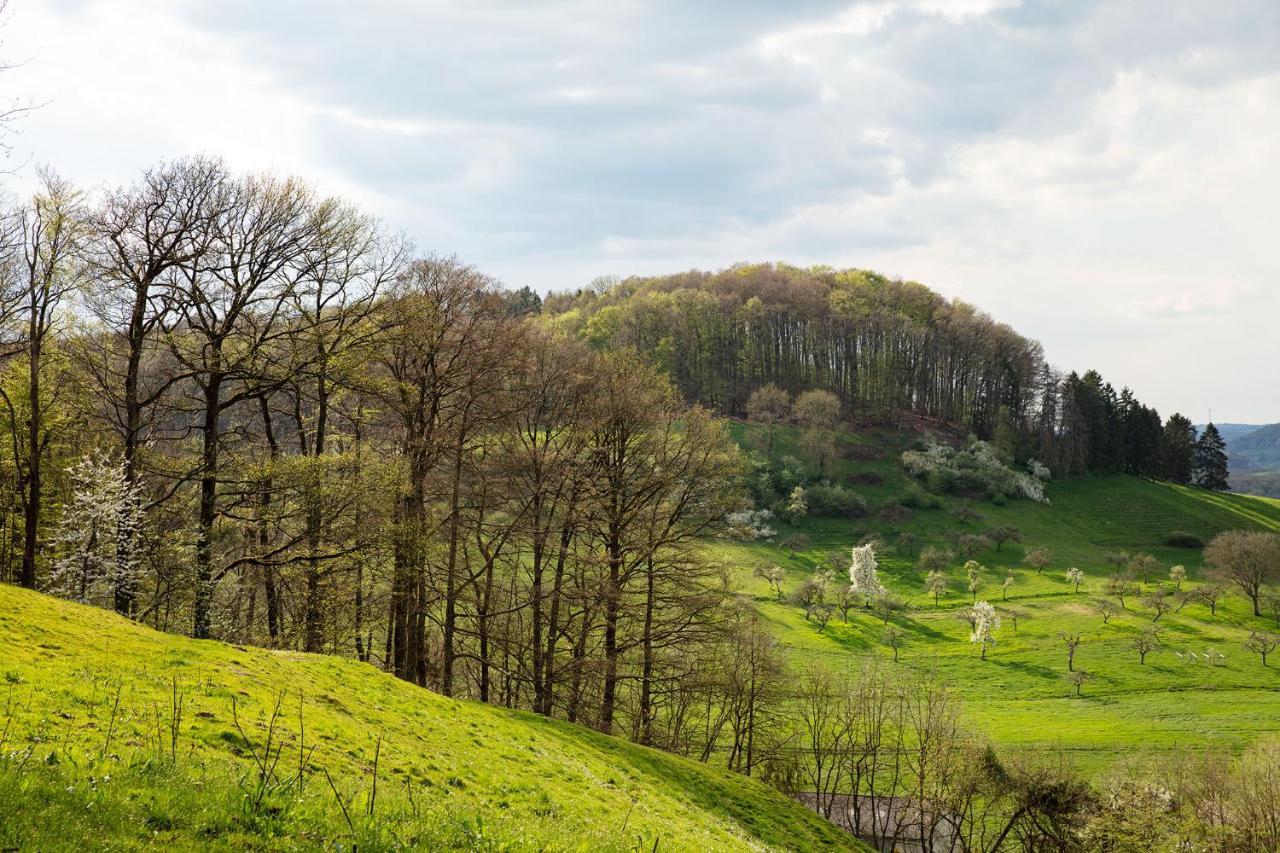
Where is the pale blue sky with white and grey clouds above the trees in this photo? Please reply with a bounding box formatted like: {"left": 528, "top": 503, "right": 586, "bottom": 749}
{"left": 0, "top": 0, "right": 1280, "bottom": 423}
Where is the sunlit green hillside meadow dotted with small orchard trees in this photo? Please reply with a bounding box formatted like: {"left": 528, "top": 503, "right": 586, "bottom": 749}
{"left": 712, "top": 427, "right": 1280, "bottom": 771}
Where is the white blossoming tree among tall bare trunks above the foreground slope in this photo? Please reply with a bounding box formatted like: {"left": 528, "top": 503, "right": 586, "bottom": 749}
{"left": 50, "top": 452, "right": 143, "bottom": 606}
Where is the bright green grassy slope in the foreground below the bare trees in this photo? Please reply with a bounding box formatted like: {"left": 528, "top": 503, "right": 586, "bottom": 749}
{"left": 0, "top": 585, "right": 851, "bottom": 850}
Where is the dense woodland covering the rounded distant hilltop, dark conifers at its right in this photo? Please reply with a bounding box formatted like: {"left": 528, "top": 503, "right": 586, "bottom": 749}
{"left": 541, "top": 264, "right": 1225, "bottom": 485}
